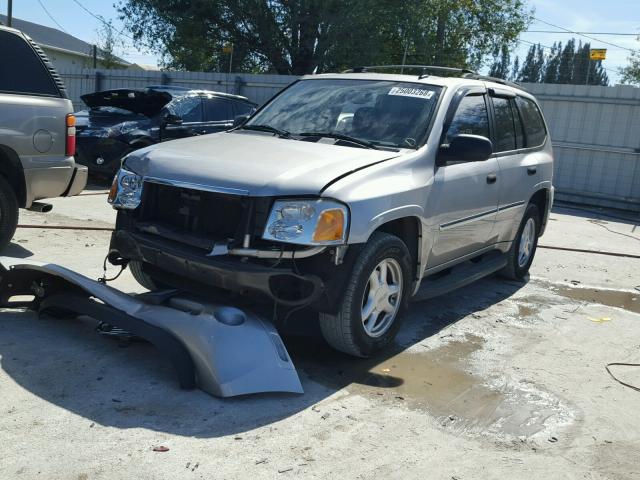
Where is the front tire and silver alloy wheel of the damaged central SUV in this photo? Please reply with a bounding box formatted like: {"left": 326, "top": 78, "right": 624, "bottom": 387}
{"left": 320, "top": 232, "right": 412, "bottom": 358}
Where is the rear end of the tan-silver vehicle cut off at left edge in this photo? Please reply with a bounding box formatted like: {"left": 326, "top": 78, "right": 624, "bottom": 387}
{"left": 0, "top": 26, "right": 87, "bottom": 249}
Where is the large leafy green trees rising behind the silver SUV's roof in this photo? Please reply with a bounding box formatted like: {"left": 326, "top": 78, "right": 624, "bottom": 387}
{"left": 118, "top": 0, "right": 530, "bottom": 75}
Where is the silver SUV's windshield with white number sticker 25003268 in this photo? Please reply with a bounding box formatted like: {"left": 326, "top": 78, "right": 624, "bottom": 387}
{"left": 246, "top": 79, "right": 442, "bottom": 148}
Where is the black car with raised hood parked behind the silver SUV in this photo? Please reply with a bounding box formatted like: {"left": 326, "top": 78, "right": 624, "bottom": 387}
{"left": 75, "top": 86, "right": 256, "bottom": 176}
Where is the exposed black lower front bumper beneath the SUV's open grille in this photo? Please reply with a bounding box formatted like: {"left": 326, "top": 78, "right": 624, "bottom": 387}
{"left": 110, "top": 230, "right": 325, "bottom": 306}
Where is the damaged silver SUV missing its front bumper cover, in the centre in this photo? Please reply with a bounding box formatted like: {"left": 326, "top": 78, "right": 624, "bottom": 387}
{"left": 109, "top": 67, "right": 553, "bottom": 356}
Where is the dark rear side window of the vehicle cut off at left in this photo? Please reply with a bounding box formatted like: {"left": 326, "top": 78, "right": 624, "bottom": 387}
{"left": 0, "top": 31, "right": 60, "bottom": 97}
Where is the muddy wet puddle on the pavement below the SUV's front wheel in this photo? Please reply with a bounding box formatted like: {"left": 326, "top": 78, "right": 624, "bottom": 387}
{"left": 288, "top": 335, "right": 559, "bottom": 436}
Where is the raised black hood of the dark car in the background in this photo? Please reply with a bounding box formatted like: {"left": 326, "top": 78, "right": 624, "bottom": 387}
{"left": 80, "top": 88, "right": 172, "bottom": 117}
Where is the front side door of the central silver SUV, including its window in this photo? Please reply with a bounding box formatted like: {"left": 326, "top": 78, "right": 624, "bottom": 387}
{"left": 427, "top": 92, "right": 499, "bottom": 268}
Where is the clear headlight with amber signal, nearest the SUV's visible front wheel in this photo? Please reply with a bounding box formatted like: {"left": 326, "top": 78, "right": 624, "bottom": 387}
{"left": 262, "top": 199, "right": 349, "bottom": 245}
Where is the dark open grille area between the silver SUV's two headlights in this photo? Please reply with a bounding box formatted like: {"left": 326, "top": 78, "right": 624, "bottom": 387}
{"left": 136, "top": 182, "right": 268, "bottom": 251}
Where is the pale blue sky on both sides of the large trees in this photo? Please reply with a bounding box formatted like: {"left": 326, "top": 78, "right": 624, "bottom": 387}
{"left": 0, "top": 0, "right": 640, "bottom": 84}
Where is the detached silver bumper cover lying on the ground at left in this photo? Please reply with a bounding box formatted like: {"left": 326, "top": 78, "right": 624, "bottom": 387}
{"left": 0, "top": 257, "right": 303, "bottom": 397}
